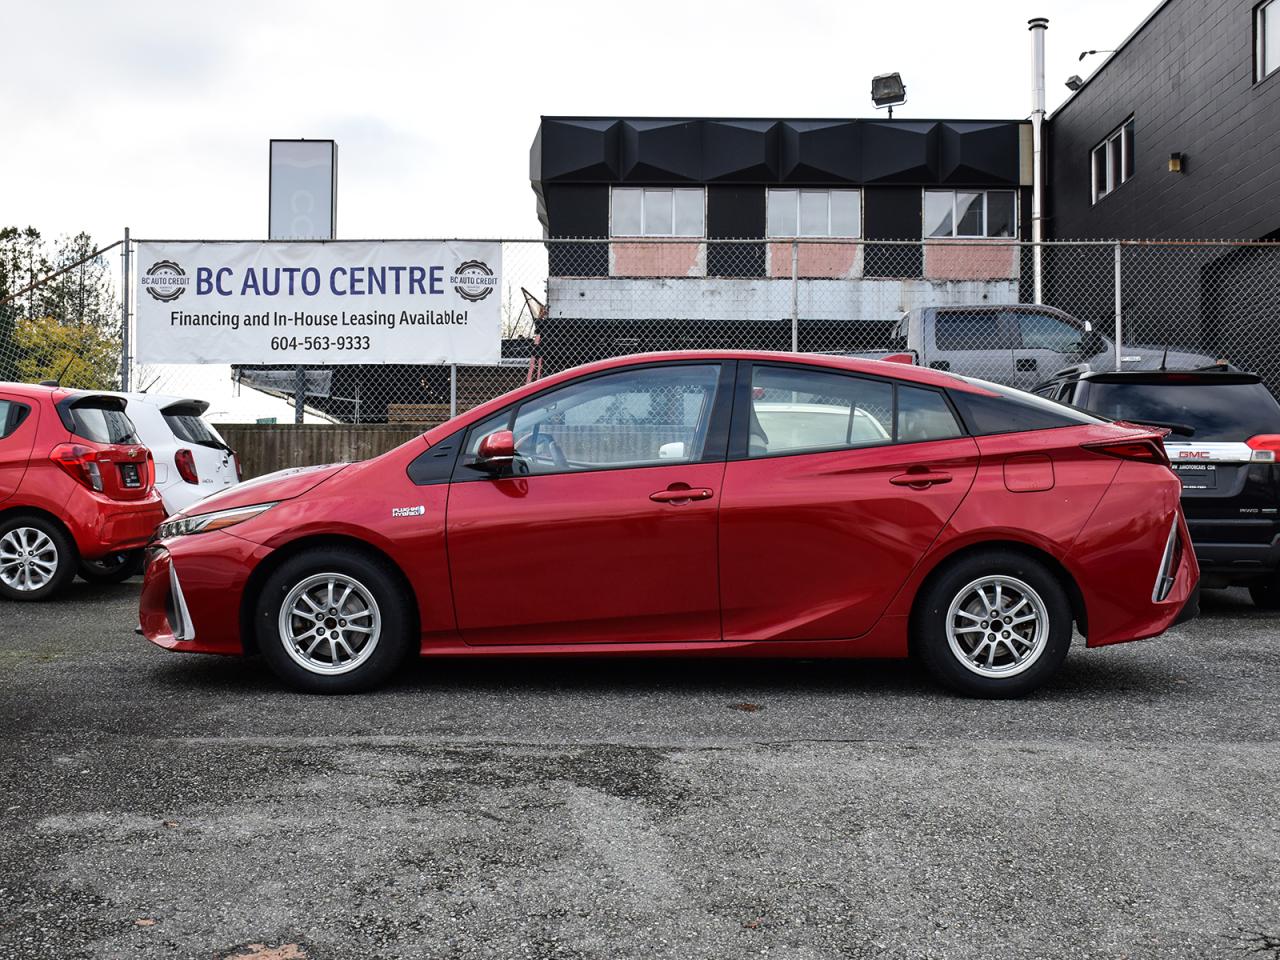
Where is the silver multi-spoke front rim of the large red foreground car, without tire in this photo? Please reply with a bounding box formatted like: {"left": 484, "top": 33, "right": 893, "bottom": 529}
{"left": 278, "top": 573, "right": 383, "bottom": 676}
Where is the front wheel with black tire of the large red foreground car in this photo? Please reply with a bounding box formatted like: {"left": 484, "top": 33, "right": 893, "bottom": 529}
{"left": 253, "top": 547, "right": 416, "bottom": 694}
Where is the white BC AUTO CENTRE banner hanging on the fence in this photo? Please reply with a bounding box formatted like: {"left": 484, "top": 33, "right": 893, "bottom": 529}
{"left": 134, "top": 241, "right": 502, "bottom": 365}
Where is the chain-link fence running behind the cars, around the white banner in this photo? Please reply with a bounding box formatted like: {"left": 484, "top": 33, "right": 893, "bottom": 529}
{"left": 0, "top": 238, "right": 1280, "bottom": 424}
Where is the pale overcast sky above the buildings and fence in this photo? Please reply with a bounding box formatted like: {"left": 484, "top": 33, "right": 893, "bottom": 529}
{"left": 0, "top": 0, "right": 1156, "bottom": 248}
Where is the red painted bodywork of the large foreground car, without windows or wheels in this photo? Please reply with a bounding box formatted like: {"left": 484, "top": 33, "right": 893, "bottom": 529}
{"left": 141, "top": 352, "right": 1198, "bottom": 658}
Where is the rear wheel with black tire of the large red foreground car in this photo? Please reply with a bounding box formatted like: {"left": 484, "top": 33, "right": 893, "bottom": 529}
{"left": 911, "top": 549, "right": 1074, "bottom": 699}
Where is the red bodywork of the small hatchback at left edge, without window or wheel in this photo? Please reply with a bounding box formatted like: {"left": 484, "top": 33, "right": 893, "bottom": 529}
{"left": 0, "top": 384, "right": 165, "bottom": 559}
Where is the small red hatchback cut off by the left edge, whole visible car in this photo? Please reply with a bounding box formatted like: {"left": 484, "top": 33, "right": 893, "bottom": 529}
{"left": 0, "top": 383, "right": 165, "bottom": 600}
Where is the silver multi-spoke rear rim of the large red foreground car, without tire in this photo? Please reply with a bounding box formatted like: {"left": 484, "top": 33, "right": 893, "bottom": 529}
{"left": 947, "top": 576, "right": 1048, "bottom": 677}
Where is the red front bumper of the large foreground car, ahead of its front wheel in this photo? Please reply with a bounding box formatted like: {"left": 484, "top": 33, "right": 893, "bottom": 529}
{"left": 138, "top": 531, "right": 270, "bottom": 654}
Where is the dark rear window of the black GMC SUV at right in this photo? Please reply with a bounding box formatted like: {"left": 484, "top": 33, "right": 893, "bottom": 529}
{"left": 1088, "top": 379, "right": 1280, "bottom": 440}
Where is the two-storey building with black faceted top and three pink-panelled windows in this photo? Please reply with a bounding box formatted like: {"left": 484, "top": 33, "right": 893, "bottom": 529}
{"left": 530, "top": 116, "right": 1032, "bottom": 369}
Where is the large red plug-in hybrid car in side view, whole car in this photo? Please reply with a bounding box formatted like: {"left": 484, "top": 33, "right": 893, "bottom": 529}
{"left": 141, "top": 352, "right": 1198, "bottom": 696}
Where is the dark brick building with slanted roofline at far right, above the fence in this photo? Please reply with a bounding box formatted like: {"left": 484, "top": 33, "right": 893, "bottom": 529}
{"left": 1046, "top": 0, "right": 1280, "bottom": 239}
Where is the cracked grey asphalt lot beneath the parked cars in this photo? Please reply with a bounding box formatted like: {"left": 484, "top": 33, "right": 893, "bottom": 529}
{"left": 0, "top": 584, "right": 1280, "bottom": 960}
